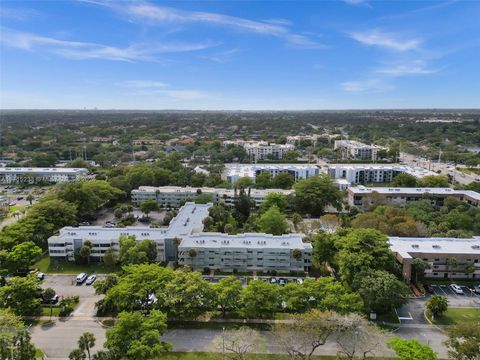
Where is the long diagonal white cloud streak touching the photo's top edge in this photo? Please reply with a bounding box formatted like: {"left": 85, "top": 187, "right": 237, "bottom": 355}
{"left": 83, "top": 0, "right": 323, "bottom": 48}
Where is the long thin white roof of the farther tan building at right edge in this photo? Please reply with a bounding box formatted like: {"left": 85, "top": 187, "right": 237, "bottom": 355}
{"left": 349, "top": 186, "right": 480, "bottom": 200}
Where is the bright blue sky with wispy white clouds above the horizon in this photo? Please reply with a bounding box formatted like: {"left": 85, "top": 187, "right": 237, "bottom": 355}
{"left": 0, "top": 0, "right": 480, "bottom": 110}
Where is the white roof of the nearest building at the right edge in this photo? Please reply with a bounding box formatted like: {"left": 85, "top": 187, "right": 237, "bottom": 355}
{"left": 388, "top": 236, "right": 480, "bottom": 259}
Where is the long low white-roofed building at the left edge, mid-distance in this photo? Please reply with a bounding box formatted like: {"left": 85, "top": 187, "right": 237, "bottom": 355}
{"left": 0, "top": 167, "right": 88, "bottom": 184}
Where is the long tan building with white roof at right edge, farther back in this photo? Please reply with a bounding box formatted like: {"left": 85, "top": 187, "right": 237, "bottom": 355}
{"left": 347, "top": 186, "right": 480, "bottom": 210}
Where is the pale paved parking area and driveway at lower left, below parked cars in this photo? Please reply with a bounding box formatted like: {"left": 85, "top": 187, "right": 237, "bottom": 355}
{"left": 42, "top": 274, "right": 103, "bottom": 317}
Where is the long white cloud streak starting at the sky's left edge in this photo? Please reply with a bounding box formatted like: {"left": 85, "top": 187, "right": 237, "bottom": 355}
{"left": 0, "top": 28, "right": 218, "bottom": 61}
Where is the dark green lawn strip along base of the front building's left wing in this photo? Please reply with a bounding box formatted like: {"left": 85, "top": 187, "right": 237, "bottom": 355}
{"left": 33, "top": 256, "right": 120, "bottom": 274}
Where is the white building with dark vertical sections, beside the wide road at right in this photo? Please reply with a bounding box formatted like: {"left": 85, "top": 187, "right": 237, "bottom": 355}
{"left": 322, "top": 164, "right": 438, "bottom": 184}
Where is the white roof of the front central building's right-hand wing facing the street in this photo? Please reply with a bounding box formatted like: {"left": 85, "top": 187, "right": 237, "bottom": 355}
{"left": 180, "top": 233, "right": 312, "bottom": 249}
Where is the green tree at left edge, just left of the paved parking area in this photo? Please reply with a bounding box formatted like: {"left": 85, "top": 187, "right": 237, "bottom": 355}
{"left": 0, "top": 277, "right": 40, "bottom": 316}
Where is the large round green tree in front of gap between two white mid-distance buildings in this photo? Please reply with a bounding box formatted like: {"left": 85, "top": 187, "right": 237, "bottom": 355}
{"left": 293, "top": 174, "right": 343, "bottom": 216}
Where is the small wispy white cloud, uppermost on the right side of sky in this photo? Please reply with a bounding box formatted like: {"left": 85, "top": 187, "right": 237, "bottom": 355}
{"left": 349, "top": 30, "right": 422, "bottom": 52}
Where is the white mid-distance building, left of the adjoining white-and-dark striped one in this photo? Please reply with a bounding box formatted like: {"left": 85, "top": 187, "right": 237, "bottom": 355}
{"left": 222, "top": 164, "right": 320, "bottom": 184}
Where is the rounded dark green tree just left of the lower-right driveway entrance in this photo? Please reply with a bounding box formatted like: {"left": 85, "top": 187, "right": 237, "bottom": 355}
{"left": 355, "top": 270, "right": 410, "bottom": 313}
